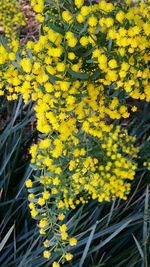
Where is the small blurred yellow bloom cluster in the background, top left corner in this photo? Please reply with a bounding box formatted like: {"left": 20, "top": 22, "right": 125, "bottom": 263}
{"left": 0, "top": 0, "right": 25, "bottom": 40}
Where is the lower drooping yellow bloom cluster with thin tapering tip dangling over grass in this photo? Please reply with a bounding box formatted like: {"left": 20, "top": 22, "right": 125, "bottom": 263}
{"left": 26, "top": 124, "right": 138, "bottom": 266}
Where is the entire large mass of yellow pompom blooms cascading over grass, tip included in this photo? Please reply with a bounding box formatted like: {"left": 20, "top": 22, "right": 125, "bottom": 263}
{"left": 0, "top": 0, "right": 150, "bottom": 267}
